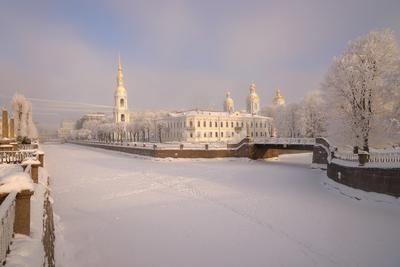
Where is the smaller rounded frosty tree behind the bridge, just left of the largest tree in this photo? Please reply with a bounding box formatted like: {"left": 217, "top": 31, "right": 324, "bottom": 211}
{"left": 300, "top": 91, "right": 326, "bottom": 137}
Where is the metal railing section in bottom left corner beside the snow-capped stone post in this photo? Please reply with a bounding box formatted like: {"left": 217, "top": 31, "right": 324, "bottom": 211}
{"left": 0, "top": 191, "right": 17, "bottom": 265}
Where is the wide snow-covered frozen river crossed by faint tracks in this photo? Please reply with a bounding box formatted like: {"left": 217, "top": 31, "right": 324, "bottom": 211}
{"left": 44, "top": 145, "right": 400, "bottom": 267}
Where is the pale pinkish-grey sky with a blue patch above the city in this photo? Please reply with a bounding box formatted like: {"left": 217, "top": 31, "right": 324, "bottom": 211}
{"left": 0, "top": 0, "right": 400, "bottom": 130}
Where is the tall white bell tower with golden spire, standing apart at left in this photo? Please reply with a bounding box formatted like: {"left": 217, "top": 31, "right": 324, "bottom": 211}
{"left": 114, "top": 56, "right": 129, "bottom": 123}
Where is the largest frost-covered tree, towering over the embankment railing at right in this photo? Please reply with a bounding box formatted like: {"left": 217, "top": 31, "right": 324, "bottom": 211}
{"left": 322, "top": 30, "right": 400, "bottom": 151}
